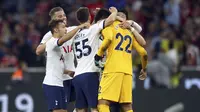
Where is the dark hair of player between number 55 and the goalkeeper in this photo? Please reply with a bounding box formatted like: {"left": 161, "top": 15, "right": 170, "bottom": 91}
{"left": 94, "top": 8, "right": 111, "bottom": 23}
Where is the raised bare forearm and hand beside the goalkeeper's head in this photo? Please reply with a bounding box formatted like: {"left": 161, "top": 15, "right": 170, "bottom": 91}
{"left": 104, "top": 7, "right": 118, "bottom": 27}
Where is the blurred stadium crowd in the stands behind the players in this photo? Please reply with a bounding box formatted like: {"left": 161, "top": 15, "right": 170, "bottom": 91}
{"left": 0, "top": 0, "right": 200, "bottom": 86}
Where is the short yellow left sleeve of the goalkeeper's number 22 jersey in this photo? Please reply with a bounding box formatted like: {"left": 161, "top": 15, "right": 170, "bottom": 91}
{"left": 102, "top": 27, "right": 113, "bottom": 40}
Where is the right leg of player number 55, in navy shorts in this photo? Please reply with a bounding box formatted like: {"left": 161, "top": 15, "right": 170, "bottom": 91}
{"left": 80, "top": 72, "right": 99, "bottom": 112}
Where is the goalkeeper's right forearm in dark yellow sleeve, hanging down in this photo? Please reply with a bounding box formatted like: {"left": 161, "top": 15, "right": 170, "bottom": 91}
{"left": 133, "top": 39, "right": 148, "bottom": 71}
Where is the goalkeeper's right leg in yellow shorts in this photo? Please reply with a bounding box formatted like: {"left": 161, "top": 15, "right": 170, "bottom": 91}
{"left": 119, "top": 74, "right": 133, "bottom": 112}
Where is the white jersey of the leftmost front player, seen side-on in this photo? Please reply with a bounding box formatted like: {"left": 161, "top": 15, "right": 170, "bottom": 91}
{"left": 43, "top": 37, "right": 64, "bottom": 87}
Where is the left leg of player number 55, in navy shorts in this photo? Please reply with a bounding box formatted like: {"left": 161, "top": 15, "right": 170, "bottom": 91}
{"left": 72, "top": 75, "right": 88, "bottom": 112}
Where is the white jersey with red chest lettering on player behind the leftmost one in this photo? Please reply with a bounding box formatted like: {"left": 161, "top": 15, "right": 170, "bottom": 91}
{"left": 40, "top": 26, "right": 76, "bottom": 80}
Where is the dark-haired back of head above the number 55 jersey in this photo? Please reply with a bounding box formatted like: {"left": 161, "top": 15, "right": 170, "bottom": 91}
{"left": 76, "top": 7, "right": 90, "bottom": 23}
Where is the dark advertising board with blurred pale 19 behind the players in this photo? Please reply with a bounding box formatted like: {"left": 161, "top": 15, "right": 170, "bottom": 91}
{"left": 0, "top": 71, "right": 200, "bottom": 112}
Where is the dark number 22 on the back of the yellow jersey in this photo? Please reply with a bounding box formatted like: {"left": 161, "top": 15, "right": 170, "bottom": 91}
{"left": 115, "top": 33, "right": 132, "bottom": 53}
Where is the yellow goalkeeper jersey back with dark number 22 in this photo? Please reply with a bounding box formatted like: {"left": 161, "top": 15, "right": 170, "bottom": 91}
{"left": 102, "top": 21, "right": 134, "bottom": 74}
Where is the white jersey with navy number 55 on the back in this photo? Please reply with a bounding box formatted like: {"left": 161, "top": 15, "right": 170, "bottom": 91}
{"left": 73, "top": 20, "right": 104, "bottom": 76}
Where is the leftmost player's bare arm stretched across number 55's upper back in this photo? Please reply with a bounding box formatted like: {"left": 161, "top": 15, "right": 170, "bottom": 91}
{"left": 57, "top": 23, "right": 89, "bottom": 46}
